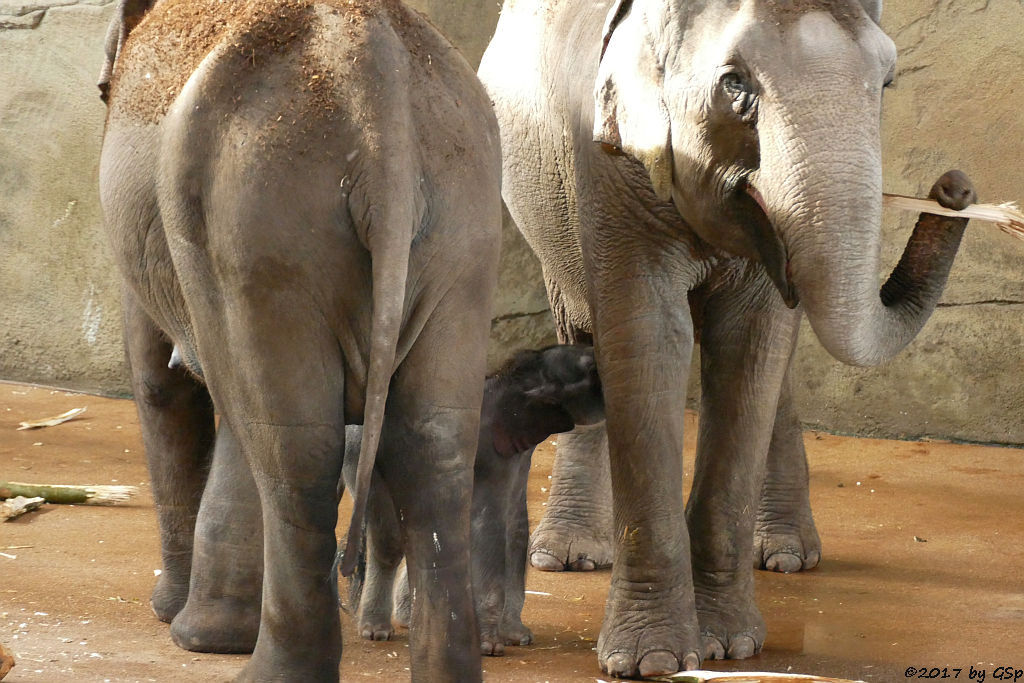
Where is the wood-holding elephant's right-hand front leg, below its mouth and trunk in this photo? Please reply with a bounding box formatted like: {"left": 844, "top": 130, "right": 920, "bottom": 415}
{"left": 687, "top": 262, "right": 799, "bottom": 659}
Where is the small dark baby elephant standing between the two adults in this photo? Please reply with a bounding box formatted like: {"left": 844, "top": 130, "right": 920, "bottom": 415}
{"left": 343, "top": 345, "right": 604, "bottom": 655}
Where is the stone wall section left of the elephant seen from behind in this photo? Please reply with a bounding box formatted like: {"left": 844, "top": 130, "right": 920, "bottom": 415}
{"left": 0, "top": 0, "right": 127, "bottom": 393}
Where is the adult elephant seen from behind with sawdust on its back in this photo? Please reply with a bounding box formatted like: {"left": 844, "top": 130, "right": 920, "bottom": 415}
{"left": 99, "top": 0, "right": 502, "bottom": 681}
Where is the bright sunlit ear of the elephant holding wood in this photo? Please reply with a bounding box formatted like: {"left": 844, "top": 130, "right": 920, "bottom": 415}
{"left": 594, "top": 0, "right": 673, "bottom": 201}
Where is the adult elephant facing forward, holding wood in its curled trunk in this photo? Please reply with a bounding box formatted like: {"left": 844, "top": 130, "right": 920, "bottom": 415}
{"left": 479, "top": 0, "right": 975, "bottom": 676}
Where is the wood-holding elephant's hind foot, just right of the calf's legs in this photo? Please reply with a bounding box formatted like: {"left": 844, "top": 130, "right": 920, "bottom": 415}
{"left": 529, "top": 509, "right": 614, "bottom": 571}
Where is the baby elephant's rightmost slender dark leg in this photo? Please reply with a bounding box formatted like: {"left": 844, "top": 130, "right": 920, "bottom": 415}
{"left": 501, "top": 450, "right": 534, "bottom": 645}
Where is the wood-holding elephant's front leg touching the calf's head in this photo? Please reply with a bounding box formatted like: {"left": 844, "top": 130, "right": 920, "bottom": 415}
{"left": 593, "top": 255, "right": 701, "bottom": 677}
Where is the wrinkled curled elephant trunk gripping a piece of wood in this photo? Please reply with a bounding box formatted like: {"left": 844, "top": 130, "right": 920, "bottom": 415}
{"left": 762, "top": 105, "right": 974, "bottom": 366}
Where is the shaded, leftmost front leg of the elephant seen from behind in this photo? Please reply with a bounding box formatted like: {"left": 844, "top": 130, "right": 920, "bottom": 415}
{"left": 124, "top": 288, "right": 214, "bottom": 623}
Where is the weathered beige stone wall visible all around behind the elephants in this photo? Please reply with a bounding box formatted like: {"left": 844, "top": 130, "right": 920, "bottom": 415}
{"left": 0, "top": 0, "right": 1024, "bottom": 444}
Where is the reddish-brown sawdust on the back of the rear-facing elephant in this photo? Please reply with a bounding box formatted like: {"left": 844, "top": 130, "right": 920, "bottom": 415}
{"left": 111, "top": 0, "right": 409, "bottom": 123}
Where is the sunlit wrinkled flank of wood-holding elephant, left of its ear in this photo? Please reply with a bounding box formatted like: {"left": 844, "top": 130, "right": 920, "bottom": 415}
{"left": 479, "top": 0, "right": 608, "bottom": 331}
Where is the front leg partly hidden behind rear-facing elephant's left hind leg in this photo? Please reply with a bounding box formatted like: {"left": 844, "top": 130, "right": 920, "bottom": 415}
{"left": 171, "top": 422, "right": 263, "bottom": 652}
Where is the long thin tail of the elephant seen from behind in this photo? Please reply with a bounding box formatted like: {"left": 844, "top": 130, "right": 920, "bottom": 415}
{"left": 340, "top": 174, "right": 420, "bottom": 577}
